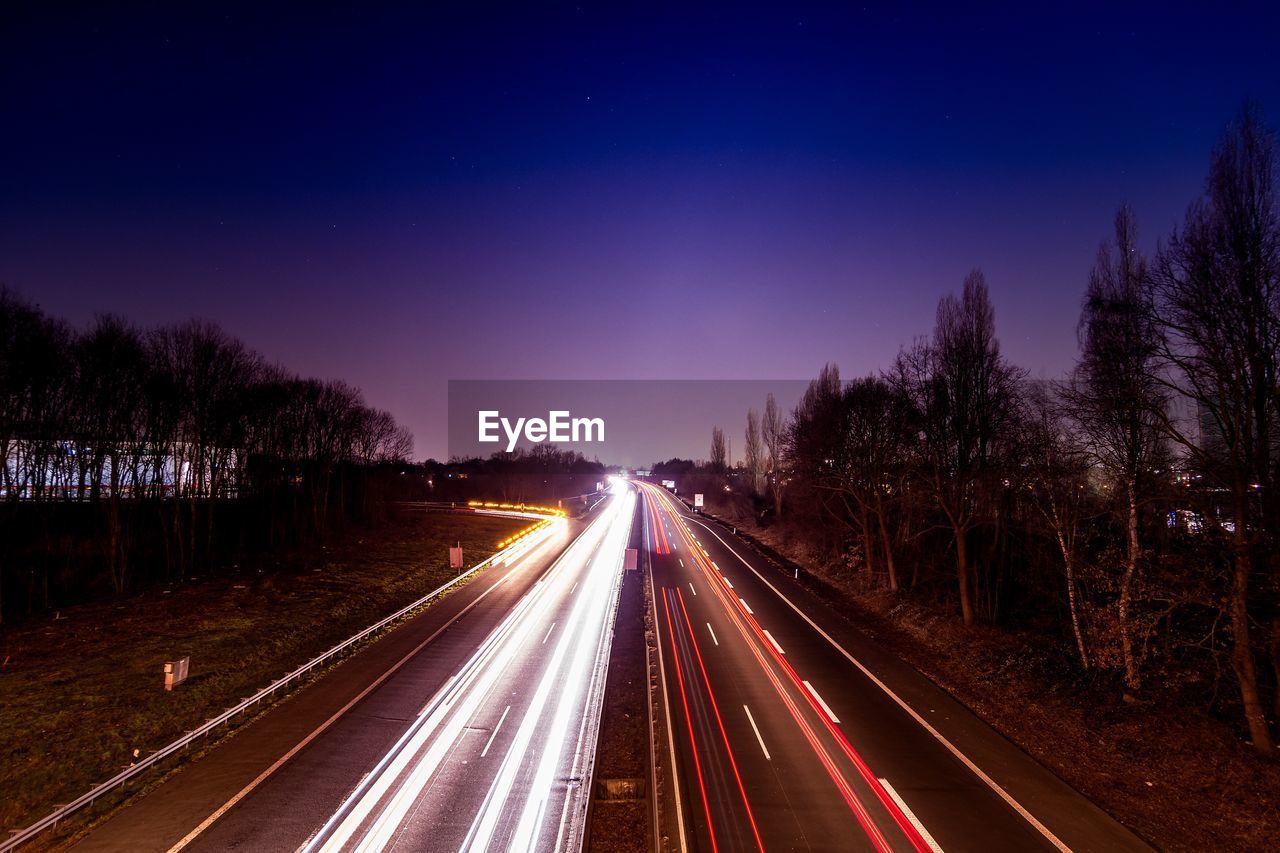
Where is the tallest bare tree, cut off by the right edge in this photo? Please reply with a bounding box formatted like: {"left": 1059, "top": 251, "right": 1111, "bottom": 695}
{"left": 1153, "top": 105, "right": 1280, "bottom": 757}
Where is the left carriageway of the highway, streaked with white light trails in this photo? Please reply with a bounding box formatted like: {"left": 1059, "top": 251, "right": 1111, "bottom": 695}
{"left": 78, "top": 484, "right": 637, "bottom": 850}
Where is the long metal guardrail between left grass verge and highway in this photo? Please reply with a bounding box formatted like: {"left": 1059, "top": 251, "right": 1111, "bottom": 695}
{"left": 0, "top": 510, "right": 553, "bottom": 853}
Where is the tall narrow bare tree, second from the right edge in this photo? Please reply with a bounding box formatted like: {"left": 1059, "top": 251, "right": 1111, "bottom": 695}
{"left": 1068, "top": 206, "right": 1169, "bottom": 689}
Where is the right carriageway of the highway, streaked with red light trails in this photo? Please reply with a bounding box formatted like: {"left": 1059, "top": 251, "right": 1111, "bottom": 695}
{"left": 641, "top": 484, "right": 1148, "bottom": 850}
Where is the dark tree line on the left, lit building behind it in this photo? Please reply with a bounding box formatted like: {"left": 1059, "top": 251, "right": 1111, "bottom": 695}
{"left": 0, "top": 295, "right": 412, "bottom": 617}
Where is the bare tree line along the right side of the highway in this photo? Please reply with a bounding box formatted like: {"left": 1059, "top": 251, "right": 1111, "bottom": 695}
{"left": 710, "top": 105, "right": 1280, "bottom": 757}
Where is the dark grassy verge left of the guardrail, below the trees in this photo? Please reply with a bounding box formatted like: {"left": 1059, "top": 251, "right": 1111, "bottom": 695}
{"left": 0, "top": 512, "right": 527, "bottom": 830}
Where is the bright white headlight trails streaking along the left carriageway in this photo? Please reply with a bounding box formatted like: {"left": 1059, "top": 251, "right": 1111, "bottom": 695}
{"left": 306, "top": 485, "right": 636, "bottom": 850}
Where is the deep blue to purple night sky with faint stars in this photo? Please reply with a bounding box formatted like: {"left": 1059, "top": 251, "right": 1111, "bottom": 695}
{"left": 0, "top": 3, "right": 1280, "bottom": 457}
